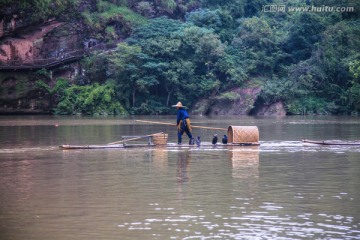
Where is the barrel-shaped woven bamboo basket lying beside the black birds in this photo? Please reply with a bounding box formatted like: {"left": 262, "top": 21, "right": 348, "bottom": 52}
{"left": 228, "top": 126, "right": 259, "bottom": 143}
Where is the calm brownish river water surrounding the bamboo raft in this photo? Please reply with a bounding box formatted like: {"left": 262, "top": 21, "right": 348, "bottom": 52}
{"left": 0, "top": 116, "right": 360, "bottom": 240}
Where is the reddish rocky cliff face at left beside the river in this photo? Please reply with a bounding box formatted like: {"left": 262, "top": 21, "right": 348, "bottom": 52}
{"left": 0, "top": 17, "right": 83, "bottom": 114}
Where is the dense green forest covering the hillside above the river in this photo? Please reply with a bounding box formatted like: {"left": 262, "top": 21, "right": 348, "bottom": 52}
{"left": 0, "top": 0, "right": 360, "bottom": 114}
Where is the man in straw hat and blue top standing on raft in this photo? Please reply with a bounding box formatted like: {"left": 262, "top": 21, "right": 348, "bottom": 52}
{"left": 173, "top": 102, "right": 194, "bottom": 145}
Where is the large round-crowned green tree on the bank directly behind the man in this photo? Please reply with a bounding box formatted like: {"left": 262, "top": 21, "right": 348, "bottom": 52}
{"left": 127, "top": 18, "right": 226, "bottom": 107}
